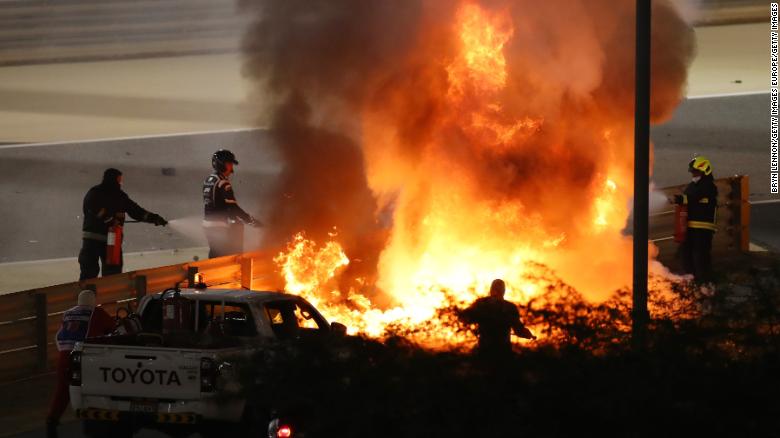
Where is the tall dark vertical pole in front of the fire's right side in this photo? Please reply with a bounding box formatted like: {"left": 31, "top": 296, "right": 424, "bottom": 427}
{"left": 631, "top": 0, "right": 652, "bottom": 350}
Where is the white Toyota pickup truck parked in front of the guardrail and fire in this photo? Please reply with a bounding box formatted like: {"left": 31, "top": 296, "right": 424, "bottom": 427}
{"left": 70, "top": 289, "right": 346, "bottom": 438}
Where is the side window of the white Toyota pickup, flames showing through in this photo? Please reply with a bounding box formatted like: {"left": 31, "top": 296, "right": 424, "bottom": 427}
{"left": 265, "top": 300, "right": 328, "bottom": 339}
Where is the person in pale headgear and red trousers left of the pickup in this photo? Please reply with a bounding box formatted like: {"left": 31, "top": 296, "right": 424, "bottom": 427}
{"left": 46, "top": 290, "right": 116, "bottom": 438}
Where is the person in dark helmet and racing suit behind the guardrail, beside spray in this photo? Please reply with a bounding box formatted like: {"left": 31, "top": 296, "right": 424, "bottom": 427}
{"left": 203, "top": 149, "right": 261, "bottom": 258}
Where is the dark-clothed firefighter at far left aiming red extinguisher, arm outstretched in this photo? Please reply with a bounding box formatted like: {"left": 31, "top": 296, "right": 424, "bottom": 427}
{"left": 79, "top": 168, "right": 168, "bottom": 281}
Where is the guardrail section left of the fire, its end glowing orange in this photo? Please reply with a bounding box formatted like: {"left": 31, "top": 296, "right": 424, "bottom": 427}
{"left": 0, "top": 252, "right": 281, "bottom": 382}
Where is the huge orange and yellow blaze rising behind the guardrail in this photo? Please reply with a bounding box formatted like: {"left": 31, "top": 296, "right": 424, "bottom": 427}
{"left": 274, "top": 1, "right": 684, "bottom": 347}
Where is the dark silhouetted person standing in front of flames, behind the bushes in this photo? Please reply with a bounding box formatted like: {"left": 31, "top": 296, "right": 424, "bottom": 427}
{"left": 461, "top": 279, "right": 536, "bottom": 357}
